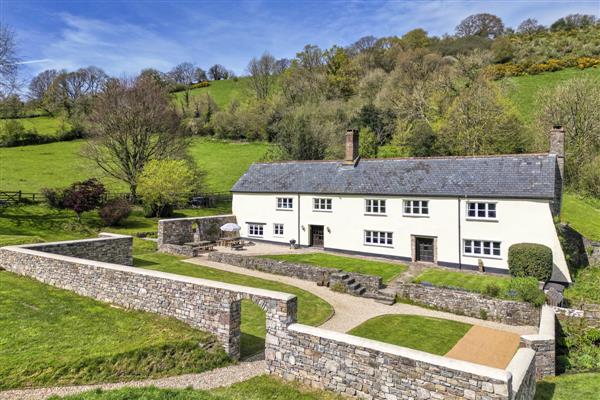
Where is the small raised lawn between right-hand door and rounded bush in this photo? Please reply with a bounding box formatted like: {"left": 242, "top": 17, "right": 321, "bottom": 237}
{"left": 413, "top": 268, "right": 510, "bottom": 293}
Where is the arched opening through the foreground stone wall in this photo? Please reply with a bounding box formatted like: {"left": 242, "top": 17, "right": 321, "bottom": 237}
{"left": 240, "top": 300, "right": 267, "bottom": 360}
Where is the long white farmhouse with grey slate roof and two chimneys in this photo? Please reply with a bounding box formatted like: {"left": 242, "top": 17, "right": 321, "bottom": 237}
{"left": 232, "top": 128, "right": 570, "bottom": 282}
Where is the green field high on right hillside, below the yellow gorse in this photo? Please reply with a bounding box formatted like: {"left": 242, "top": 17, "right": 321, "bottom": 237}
{"left": 500, "top": 68, "right": 600, "bottom": 123}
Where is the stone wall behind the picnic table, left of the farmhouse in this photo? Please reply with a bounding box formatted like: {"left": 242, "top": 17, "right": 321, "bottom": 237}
{"left": 158, "top": 215, "right": 236, "bottom": 247}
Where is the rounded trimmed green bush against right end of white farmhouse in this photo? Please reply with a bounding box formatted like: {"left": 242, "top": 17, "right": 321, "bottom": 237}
{"left": 508, "top": 243, "right": 553, "bottom": 282}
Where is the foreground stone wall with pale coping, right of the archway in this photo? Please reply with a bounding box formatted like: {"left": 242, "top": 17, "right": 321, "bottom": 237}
{"left": 265, "top": 324, "right": 535, "bottom": 400}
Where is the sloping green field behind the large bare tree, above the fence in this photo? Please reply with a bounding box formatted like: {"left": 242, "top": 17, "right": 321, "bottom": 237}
{"left": 0, "top": 138, "right": 268, "bottom": 192}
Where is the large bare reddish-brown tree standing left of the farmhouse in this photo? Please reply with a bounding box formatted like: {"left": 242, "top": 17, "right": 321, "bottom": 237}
{"left": 84, "top": 77, "right": 188, "bottom": 199}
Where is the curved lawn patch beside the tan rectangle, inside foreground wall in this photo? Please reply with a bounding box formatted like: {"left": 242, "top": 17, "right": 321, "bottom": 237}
{"left": 348, "top": 315, "right": 472, "bottom": 355}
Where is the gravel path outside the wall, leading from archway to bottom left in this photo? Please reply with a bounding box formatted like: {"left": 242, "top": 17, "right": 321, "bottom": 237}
{"left": 0, "top": 360, "right": 267, "bottom": 400}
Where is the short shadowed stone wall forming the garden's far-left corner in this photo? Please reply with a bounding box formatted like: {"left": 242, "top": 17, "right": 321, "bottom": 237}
{"left": 20, "top": 233, "right": 133, "bottom": 265}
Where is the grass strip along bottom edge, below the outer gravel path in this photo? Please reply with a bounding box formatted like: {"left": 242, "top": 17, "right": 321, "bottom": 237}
{"left": 49, "top": 375, "right": 343, "bottom": 400}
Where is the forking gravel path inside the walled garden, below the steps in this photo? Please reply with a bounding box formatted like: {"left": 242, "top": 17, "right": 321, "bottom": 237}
{"left": 183, "top": 256, "right": 537, "bottom": 335}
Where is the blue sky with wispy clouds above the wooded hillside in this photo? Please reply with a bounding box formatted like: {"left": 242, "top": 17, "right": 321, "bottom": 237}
{"left": 0, "top": 0, "right": 600, "bottom": 78}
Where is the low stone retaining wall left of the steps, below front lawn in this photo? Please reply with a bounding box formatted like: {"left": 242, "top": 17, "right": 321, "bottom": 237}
{"left": 208, "top": 252, "right": 383, "bottom": 293}
